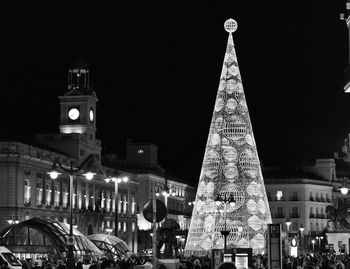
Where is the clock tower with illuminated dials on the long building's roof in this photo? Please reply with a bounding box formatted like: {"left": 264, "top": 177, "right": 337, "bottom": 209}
{"left": 36, "top": 60, "right": 101, "bottom": 162}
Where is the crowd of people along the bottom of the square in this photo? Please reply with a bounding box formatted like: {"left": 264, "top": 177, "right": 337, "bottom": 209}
{"left": 14, "top": 253, "right": 350, "bottom": 269}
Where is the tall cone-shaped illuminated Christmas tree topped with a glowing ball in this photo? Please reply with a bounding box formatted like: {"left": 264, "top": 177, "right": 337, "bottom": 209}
{"left": 185, "top": 19, "right": 271, "bottom": 256}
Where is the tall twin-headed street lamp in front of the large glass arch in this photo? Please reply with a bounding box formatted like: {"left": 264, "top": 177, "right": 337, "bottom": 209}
{"left": 47, "top": 154, "right": 95, "bottom": 269}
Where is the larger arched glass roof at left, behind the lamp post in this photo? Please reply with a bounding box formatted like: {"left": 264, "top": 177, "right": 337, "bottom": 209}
{"left": 0, "top": 218, "right": 103, "bottom": 257}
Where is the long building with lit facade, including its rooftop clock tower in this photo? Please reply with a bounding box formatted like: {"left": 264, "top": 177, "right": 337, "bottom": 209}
{"left": 0, "top": 59, "right": 138, "bottom": 252}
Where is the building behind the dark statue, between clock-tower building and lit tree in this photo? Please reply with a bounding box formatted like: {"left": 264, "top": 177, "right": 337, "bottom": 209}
{"left": 121, "top": 140, "right": 196, "bottom": 251}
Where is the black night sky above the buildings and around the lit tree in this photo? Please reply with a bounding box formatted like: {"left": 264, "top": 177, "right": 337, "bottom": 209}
{"left": 0, "top": 0, "right": 350, "bottom": 184}
